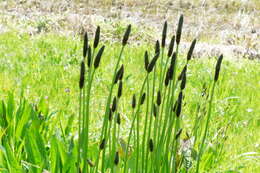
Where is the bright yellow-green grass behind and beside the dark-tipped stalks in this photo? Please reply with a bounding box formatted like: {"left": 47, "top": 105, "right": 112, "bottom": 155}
{"left": 0, "top": 32, "right": 260, "bottom": 172}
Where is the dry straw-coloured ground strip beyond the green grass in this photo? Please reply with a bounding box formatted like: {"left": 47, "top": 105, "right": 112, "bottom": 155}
{"left": 0, "top": 0, "right": 260, "bottom": 59}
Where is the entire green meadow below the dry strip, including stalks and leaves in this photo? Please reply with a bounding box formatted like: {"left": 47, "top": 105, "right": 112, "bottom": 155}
{"left": 0, "top": 1, "right": 260, "bottom": 173}
